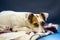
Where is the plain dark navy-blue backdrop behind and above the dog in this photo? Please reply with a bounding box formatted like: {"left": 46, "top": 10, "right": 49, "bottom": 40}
{"left": 0, "top": 0, "right": 60, "bottom": 24}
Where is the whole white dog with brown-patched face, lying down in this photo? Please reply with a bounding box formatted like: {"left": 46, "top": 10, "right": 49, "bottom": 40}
{"left": 0, "top": 11, "right": 48, "bottom": 32}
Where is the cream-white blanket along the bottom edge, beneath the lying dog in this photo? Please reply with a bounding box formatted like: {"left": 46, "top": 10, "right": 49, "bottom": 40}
{"left": 0, "top": 31, "right": 49, "bottom": 40}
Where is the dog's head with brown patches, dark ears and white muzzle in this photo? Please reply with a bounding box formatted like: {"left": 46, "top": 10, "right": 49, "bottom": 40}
{"left": 28, "top": 13, "right": 48, "bottom": 32}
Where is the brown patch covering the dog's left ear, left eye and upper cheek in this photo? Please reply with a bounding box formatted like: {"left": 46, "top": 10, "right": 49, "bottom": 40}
{"left": 28, "top": 14, "right": 39, "bottom": 28}
